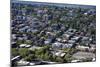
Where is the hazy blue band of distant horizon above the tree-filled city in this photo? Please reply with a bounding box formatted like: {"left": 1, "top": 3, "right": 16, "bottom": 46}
{"left": 11, "top": 0, "right": 96, "bottom": 9}
